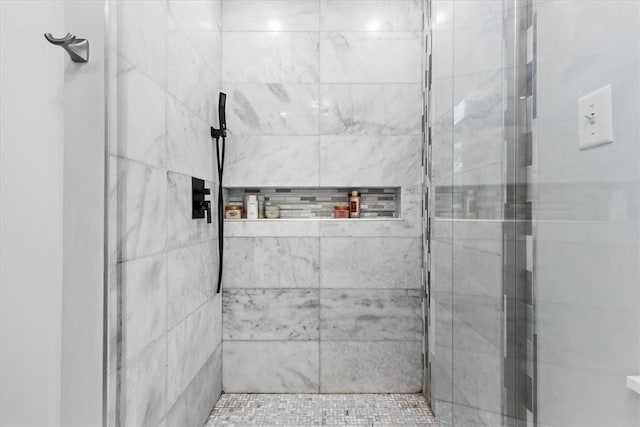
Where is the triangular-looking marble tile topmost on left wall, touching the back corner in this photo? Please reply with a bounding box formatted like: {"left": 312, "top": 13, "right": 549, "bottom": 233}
{"left": 167, "top": 0, "right": 222, "bottom": 76}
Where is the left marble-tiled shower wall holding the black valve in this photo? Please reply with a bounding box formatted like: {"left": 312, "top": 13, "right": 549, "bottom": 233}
{"left": 107, "top": 0, "right": 222, "bottom": 426}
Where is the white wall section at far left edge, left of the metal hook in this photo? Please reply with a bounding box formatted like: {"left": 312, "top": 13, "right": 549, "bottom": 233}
{"left": 0, "top": 1, "right": 65, "bottom": 425}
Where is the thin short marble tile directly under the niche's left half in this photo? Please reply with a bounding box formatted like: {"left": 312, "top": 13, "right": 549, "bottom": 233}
{"left": 224, "top": 219, "right": 320, "bottom": 237}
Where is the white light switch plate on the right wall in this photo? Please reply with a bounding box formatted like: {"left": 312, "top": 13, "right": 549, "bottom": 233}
{"left": 578, "top": 85, "right": 613, "bottom": 150}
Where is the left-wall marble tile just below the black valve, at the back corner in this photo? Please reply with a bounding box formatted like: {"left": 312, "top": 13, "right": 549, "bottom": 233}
{"left": 167, "top": 240, "right": 218, "bottom": 328}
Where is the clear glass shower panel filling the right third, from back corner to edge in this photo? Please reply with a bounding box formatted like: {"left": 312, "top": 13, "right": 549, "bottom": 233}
{"left": 425, "top": 0, "right": 640, "bottom": 426}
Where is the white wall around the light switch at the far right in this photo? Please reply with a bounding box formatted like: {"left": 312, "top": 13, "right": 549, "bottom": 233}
{"left": 534, "top": 1, "right": 640, "bottom": 426}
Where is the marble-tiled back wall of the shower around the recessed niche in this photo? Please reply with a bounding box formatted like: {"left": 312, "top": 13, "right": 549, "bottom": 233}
{"left": 222, "top": 0, "right": 423, "bottom": 393}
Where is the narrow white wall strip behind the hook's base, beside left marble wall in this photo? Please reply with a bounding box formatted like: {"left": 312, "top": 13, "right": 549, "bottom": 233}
{"left": 60, "top": 0, "right": 106, "bottom": 426}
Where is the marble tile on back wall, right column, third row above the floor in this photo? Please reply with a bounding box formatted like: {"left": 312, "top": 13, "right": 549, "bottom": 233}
{"left": 320, "top": 237, "right": 422, "bottom": 289}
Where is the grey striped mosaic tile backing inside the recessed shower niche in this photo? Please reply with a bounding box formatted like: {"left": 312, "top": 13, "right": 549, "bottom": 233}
{"left": 226, "top": 187, "right": 400, "bottom": 218}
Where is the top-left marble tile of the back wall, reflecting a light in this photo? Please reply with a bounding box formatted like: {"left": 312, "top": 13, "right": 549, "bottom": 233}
{"left": 222, "top": 0, "right": 320, "bottom": 31}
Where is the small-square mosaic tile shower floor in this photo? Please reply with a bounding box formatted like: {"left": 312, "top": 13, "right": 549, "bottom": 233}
{"left": 205, "top": 394, "right": 436, "bottom": 427}
